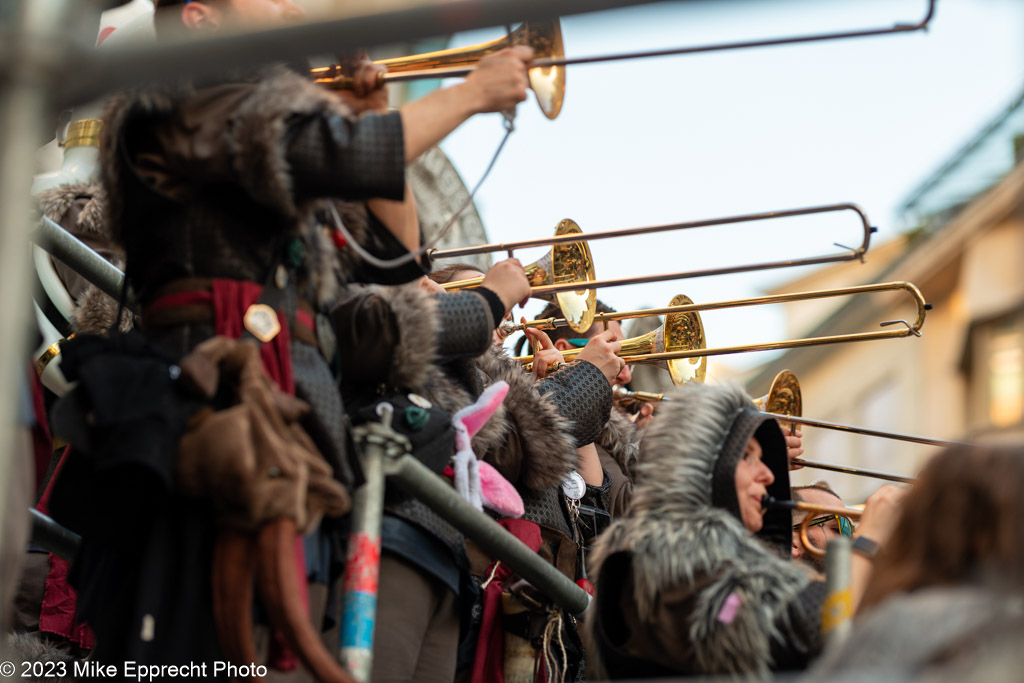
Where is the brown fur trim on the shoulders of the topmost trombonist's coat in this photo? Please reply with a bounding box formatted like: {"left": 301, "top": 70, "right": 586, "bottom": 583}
{"left": 100, "top": 67, "right": 385, "bottom": 307}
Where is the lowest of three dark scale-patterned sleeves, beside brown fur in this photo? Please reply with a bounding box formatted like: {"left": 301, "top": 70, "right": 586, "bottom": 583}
{"left": 538, "top": 360, "right": 611, "bottom": 447}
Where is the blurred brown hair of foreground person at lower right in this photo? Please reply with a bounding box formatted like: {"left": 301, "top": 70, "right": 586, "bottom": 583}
{"left": 861, "top": 444, "right": 1024, "bottom": 609}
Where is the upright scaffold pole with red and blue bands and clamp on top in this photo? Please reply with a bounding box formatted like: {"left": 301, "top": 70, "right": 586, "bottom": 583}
{"left": 341, "top": 401, "right": 413, "bottom": 682}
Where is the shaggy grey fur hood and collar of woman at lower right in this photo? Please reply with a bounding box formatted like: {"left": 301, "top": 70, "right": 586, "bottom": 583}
{"left": 591, "top": 384, "right": 809, "bottom": 674}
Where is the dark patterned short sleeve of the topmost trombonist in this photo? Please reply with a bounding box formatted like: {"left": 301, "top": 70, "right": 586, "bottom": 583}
{"left": 286, "top": 112, "right": 406, "bottom": 202}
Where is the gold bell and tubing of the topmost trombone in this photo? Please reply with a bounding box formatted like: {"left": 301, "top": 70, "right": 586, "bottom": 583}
{"left": 311, "top": 18, "right": 565, "bottom": 119}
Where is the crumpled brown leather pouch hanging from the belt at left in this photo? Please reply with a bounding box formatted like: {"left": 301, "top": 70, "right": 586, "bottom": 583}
{"left": 175, "top": 337, "right": 351, "bottom": 532}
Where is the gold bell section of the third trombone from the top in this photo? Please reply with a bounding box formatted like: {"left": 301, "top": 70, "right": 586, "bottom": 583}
{"left": 516, "top": 294, "right": 708, "bottom": 385}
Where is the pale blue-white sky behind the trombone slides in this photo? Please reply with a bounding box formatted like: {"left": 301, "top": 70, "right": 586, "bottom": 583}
{"left": 443, "top": 0, "right": 1024, "bottom": 376}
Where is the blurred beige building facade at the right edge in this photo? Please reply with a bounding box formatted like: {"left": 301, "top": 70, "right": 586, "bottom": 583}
{"left": 746, "top": 89, "right": 1024, "bottom": 503}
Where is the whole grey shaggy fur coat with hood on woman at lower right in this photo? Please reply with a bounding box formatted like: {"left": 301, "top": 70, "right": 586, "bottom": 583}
{"left": 591, "top": 384, "right": 823, "bottom": 677}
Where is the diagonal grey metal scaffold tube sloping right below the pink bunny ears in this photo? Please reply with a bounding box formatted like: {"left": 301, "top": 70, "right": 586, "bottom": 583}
{"left": 385, "top": 455, "right": 591, "bottom": 616}
